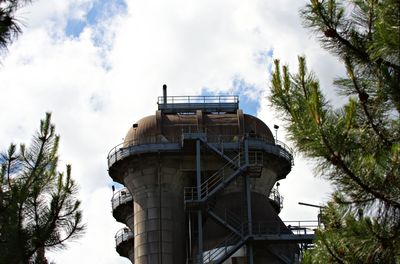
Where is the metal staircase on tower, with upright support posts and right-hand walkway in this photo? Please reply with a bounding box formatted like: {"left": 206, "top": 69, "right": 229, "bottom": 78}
{"left": 182, "top": 131, "right": 314, "bottom": 264}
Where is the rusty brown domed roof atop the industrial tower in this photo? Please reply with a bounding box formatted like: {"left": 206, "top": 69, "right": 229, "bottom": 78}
{"left": 124, "top": 109, "right": 274, "bottom": 146}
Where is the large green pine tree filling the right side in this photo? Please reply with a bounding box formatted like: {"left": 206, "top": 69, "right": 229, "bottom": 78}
{"left": 269, "top": 0, "right": 400, "bottom": 264}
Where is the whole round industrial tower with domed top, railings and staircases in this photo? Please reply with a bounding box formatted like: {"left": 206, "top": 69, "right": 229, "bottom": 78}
{"left": 108, "top": 86, "right": 313, "bottom": 264}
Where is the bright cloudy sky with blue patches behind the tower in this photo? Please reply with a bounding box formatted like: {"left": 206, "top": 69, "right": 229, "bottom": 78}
{"left": 0, "top": 0, "right": 344, "bottom": 264}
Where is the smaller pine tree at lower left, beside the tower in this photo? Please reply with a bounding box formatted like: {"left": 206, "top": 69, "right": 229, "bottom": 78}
{"left": 0, "top": 113, "right": 85, "bottom": 264}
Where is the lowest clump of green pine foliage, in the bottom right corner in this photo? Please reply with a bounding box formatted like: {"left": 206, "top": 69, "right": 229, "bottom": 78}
{"left": 303, "top": 199, "right": 400, "bottom": 263}
